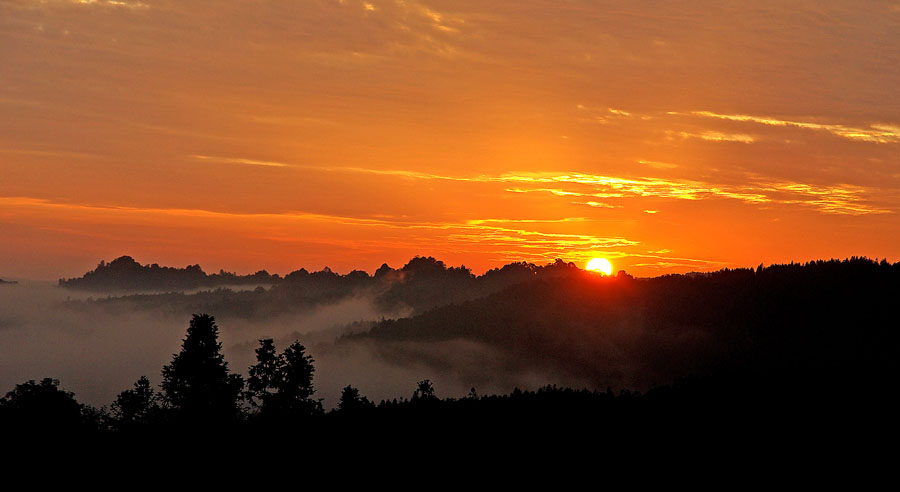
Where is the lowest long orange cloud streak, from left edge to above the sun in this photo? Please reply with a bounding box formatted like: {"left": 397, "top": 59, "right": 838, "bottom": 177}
{"left": 0, "top": 197, "right": 640, "bottom": 270}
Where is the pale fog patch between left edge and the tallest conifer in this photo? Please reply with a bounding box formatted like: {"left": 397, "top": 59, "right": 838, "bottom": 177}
{"left": 0, "top": 281, "right": 188, "bottom": 406}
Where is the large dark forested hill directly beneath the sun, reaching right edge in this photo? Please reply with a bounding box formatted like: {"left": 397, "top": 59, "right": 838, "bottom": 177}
{"left": 347, "top": 258, "right": 900, "bottom": 388}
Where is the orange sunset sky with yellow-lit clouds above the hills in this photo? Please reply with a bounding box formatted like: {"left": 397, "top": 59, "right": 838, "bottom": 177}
{"left": 0, "top": 0, "right": 900, "bottom": 279}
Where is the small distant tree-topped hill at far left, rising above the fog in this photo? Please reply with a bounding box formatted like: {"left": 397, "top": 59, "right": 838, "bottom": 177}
{"left": 59, "top": 256, "right": 281, "bottom": 291}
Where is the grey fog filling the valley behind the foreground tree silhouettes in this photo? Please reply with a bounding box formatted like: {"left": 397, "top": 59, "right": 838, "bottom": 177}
{"left": 0, "top": 281, "right": 582, "bottom": 408}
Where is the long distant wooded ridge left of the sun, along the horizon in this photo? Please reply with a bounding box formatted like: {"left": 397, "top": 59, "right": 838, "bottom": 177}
{"left": 60, "top": 257, "right": 580, "bottom": 319}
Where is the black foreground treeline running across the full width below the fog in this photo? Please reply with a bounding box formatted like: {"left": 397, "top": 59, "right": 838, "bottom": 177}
{"left": 0, "top": 306, "right": 896, "bottom": 440}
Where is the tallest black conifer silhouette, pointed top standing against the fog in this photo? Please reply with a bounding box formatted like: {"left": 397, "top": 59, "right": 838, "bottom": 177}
{"left": 162, "top": 314, "right": 244, "bottom": 421}
